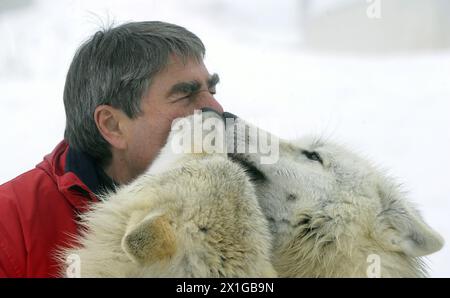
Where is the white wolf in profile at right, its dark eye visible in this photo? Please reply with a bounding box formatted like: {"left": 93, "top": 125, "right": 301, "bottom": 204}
{"left": 227, "top": 115, "right": 444, "bottom": 277}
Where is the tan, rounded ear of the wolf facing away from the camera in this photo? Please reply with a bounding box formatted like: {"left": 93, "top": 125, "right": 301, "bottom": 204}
{"left": 122, "top": 215, "right": 176, "bottom": 265}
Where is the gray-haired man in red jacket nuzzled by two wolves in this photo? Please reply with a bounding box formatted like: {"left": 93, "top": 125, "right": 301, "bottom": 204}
{"left": 0, "top": 22, "right": 223, "bottom": 277}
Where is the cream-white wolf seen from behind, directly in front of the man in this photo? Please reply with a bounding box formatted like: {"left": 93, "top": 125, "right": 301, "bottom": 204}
{"left": 59, "top": 112, "right": 276, "bottom": 277}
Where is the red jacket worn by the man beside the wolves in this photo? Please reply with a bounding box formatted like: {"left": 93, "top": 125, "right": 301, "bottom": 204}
{"left": 0, "top": 141, "right": 97, "bottom": 277}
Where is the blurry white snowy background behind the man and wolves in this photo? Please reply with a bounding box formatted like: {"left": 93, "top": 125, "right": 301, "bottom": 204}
{"left": 0, "top": 0, "right": 450, "bottom": 277}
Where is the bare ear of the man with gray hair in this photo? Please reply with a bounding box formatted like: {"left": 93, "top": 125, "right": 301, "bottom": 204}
{"left": 94, "top": 105, "right": 129, "bottom": 149}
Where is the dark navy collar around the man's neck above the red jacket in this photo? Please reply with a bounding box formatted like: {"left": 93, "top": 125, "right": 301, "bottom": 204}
{"left": 64, "top": 146, "right": 116, "bottom": 195}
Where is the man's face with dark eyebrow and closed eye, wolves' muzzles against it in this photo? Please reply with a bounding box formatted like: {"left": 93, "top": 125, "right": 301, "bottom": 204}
{"left": 125, "top": 56, "right": 223, "bottom": 177}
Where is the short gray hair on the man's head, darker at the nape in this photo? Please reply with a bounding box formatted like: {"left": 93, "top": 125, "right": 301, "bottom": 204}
{"left": 64, "top": 21, "right": 205, "bottom": 166}
